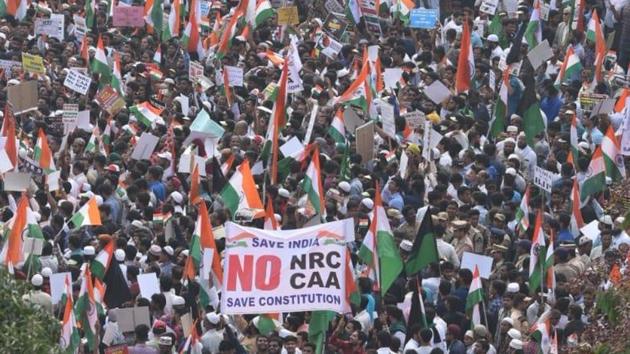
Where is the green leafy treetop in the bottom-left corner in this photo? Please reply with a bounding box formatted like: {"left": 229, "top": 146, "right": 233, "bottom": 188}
{"left": 0, "top": 267, "right": 61, "bottom": 353}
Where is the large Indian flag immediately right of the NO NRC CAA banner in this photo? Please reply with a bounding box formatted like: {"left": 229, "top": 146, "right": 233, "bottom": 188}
{"left": 359, "top": 184, "right": 403, "bottom": 294}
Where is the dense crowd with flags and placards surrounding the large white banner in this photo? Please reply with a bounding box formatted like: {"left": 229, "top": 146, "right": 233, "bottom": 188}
{"left": 0, "top": 0, "right": 630, "bottom": 354}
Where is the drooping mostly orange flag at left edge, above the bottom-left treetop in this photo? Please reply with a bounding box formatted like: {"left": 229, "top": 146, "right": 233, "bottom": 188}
{"left": 0, "top": 194, "right": 28, "bottom": 269}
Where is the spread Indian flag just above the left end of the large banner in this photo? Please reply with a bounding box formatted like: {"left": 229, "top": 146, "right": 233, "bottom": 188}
{"left": 221, "top": 160, "right": 265, "bottom": 218}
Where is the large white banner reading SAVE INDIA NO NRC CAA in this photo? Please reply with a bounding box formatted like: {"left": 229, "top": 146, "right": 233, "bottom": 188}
{"left": 221, "top": 219, "right": 354, "bottom": 315}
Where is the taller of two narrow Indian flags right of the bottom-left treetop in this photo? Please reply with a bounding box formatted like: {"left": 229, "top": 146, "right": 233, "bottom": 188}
{"left": 74, "top": 266, "right": 98, "bottom": 350}
